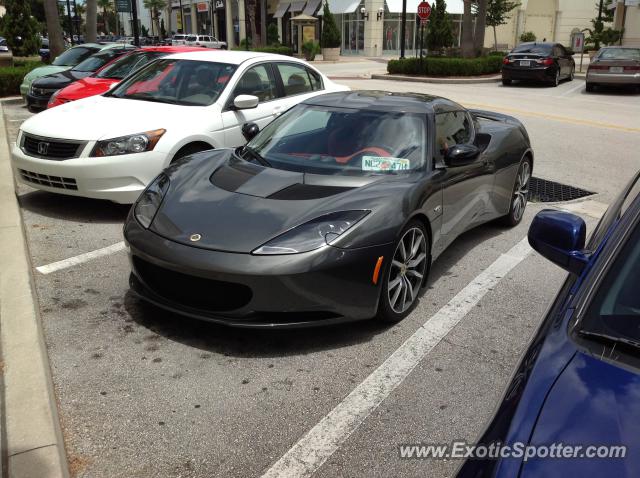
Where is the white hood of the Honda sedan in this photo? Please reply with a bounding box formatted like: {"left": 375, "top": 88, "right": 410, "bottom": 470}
{"left": 22, "top": 96, "right": 210, "bottom": 141}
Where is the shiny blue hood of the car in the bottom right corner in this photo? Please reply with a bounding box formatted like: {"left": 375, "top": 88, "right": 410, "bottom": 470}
{"left": 520, "top": 353, "right": 640, "bottom": 478}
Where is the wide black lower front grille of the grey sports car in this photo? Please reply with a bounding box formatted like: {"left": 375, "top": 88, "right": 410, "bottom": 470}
{"left": 133, "top": 256, "right": 253, "bottom": 312}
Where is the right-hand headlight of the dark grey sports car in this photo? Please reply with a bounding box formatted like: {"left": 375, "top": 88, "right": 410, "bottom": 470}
{"left": 252, "top": 210, "right": 370, "bottom": 255}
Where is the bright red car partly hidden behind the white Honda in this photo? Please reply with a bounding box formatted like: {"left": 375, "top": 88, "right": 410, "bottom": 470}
{"left": 47, "top": 46, "right": 203, "bottom": 108}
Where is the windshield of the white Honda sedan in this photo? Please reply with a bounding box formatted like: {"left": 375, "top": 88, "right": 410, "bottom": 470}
{"left": 107, "top": 59, "right": 236, "bottom": 106}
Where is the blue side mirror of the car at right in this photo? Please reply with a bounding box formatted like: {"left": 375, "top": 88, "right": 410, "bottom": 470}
{"left": 529, "top": 209, "right": 589, "bottom": 275}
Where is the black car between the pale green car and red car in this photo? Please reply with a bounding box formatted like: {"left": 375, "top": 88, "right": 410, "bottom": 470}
{"left": 26, "top": 44, "right": 136, "bottom": 112}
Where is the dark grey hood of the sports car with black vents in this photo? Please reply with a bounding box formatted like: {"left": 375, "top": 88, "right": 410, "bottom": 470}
{"left": 151, "top": 150, "right": 402, "bottom": 253}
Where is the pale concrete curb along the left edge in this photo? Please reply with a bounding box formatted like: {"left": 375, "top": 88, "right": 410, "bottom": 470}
{"left": 0, "top": 103, "right": 69, "bottom": 478}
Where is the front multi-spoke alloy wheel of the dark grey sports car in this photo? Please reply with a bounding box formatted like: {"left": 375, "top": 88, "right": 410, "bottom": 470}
{"left": 387, "top": 227, "right": 427, "bottom": 314}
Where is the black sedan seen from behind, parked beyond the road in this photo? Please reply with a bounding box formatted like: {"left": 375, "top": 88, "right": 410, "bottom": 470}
{"left": 502, "top": 42, "right": 576, "bottom": 86}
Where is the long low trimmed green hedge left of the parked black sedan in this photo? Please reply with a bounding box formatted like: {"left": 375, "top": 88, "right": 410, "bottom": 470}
{"left": 387, "top": 55, "right": 502, "bottom": 76}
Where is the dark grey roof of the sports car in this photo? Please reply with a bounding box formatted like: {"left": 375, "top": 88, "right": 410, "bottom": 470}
{"left": 303, "top": 90, "right": 465, "bottom": 113}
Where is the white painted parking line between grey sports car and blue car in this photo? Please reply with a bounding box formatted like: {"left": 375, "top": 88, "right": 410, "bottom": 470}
{"left": 263, "top": 238, "right": 531, "bottom": 478}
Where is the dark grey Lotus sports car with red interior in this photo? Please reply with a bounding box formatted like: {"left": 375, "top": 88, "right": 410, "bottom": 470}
{"left": 124, "top": 91, "right": 533, "bottom": 327}
